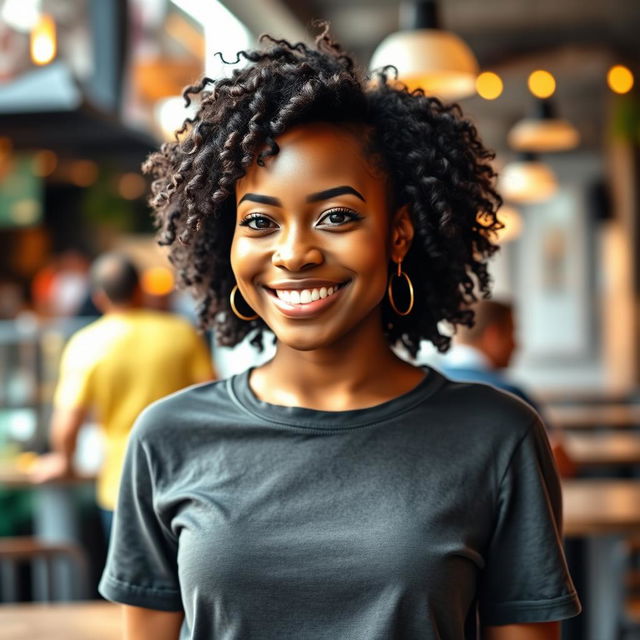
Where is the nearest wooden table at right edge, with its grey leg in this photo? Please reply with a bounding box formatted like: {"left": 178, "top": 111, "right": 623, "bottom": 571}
{"left": 562, "top": 479, "right": 640, "bottom": 640}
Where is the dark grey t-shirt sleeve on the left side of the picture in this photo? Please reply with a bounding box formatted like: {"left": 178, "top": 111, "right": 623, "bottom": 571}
{"left": 98, "top": 410, "right": 182, "bottom": 611}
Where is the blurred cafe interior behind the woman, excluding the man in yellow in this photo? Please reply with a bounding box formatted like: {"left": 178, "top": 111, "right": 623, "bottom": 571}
{"left": 0, "top": 0, "right": 640, "bottom": 640}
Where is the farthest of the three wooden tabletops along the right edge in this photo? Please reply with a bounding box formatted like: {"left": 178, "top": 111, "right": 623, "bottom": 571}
{"left": 545, "top": 404, "right": 640, "bottom": 429}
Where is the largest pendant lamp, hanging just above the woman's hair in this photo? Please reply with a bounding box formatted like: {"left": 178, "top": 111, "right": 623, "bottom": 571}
{"left": 369, "top": 0, "right": 478, "bottom": 100}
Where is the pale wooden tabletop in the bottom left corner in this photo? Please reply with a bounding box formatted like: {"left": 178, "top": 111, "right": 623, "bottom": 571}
{"left": 0, "top": 601, "right": 122, "bottom": 640}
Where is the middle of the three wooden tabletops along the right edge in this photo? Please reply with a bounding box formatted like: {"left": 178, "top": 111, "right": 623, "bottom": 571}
{"left": 563, "top": 431, "right": 640, "bottom": 467}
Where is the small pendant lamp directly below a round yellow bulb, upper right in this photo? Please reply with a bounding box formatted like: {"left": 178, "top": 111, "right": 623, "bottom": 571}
{"left": 507, "top": 99, "right": 580, "bottom": 153}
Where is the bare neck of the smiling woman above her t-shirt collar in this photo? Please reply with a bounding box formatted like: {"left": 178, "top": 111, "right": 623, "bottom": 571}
{"left": 251, "top": 315, "right": 424, "bottom": 411}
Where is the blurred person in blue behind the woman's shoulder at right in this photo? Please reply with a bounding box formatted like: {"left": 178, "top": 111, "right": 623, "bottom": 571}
{"left": 440, "top": 300, "right": 576, "bottom": 477}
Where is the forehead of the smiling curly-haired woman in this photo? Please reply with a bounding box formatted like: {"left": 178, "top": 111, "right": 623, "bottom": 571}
{"left": 236, "top": 123, "right": 385, "bottom": 199}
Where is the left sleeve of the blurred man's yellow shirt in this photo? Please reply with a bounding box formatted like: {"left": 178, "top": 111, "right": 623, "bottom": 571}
{"left": 53, "top": 336, "right": 95, "bottom": 409}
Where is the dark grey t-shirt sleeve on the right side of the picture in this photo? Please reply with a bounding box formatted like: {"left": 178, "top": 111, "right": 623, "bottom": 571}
{"left": 479, "top": 419, "right": 580, "bottom": 626}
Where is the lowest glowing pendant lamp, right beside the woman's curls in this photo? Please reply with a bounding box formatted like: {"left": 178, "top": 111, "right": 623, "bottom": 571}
{"left": 498, "top": 152, "right": 558, "bottom": 202}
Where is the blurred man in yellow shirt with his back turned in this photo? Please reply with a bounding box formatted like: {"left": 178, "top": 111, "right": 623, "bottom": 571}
{"left": 31, "top": 253, "right": 215, "bottom": 536}
